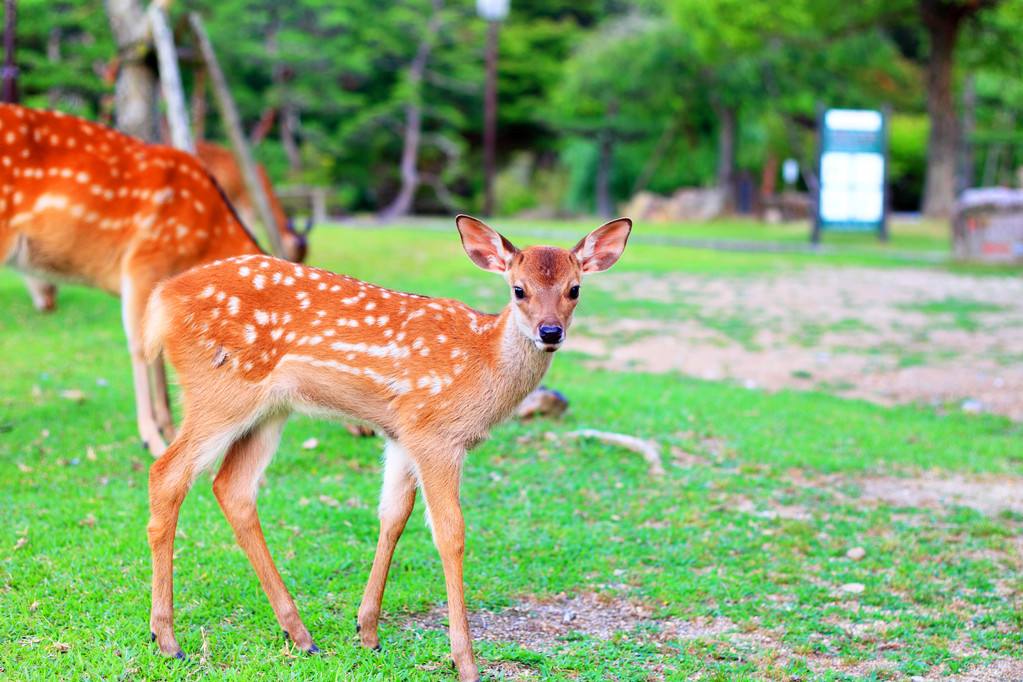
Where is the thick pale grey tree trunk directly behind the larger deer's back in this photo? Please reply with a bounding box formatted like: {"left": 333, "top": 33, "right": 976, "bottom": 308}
{"left": 105, "top": 0, "right": 160, "bottom": 142}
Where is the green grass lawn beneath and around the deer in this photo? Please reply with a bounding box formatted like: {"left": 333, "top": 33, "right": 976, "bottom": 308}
{"left": 0, "top": 223, "right": 1023, "bottom": 680}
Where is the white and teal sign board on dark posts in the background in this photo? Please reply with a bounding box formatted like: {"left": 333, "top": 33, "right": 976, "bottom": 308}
{"left": 810, "top": 109, "right": 888, "bottom": 243}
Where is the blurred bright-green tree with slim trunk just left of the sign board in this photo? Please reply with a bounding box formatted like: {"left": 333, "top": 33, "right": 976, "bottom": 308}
{"left": 670, "top": 0, "right": 913, "bottom": 204}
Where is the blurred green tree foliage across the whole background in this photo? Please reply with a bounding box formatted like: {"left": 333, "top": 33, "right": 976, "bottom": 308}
{"left": 7, "top": 0, "right": 1023, "bottom": 211}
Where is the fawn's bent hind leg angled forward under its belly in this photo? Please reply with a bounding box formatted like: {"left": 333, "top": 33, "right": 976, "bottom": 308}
{"left": 213, "top": 417, "right": 319, "bottom": 653}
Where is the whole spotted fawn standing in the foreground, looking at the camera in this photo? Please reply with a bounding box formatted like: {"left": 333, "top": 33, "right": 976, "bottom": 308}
{"left": 145, "top": 216, "right": 632, "bottom": 680}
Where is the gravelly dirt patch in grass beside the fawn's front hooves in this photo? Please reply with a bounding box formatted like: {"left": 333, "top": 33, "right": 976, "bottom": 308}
{"left": 405, "top": 592, "right": 736, "bottom": 651}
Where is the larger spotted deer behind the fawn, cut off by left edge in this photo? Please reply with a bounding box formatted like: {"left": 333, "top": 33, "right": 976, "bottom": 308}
{"left": 0, "top": 104, "right": 302, "bottom": 455}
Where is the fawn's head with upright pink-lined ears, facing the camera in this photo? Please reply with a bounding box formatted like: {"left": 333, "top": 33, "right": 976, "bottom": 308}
{"left": 455, "top": 216, "right": 632, "bottom": 353}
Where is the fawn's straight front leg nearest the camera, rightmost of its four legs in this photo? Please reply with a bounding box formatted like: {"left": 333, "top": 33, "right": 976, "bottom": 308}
{"left": 417, "top": 456, "right": 480, "bottom": 682}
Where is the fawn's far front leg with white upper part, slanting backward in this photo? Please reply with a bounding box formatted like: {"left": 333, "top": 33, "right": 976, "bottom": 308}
{"left": 356, "top": 441, "right": 415, "bottom": 648}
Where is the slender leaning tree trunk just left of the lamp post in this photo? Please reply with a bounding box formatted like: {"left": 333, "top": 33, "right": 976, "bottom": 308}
{"left": 381, "top": 0, "right": 444, "bottom": 220}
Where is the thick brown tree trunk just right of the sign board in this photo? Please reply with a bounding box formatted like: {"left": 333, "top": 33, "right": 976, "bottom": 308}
{"left": 921, "top": 0, "right": 963, "bottom": 218}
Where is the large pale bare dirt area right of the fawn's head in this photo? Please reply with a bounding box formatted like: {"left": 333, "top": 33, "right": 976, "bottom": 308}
{"left": 572, "top": 268, "right": 1023, "bottom": 419}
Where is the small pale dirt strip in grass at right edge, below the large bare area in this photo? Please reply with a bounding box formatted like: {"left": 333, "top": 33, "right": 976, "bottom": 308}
{"left": 859, "top": 475, "right": 1023, "bottom": 514}
